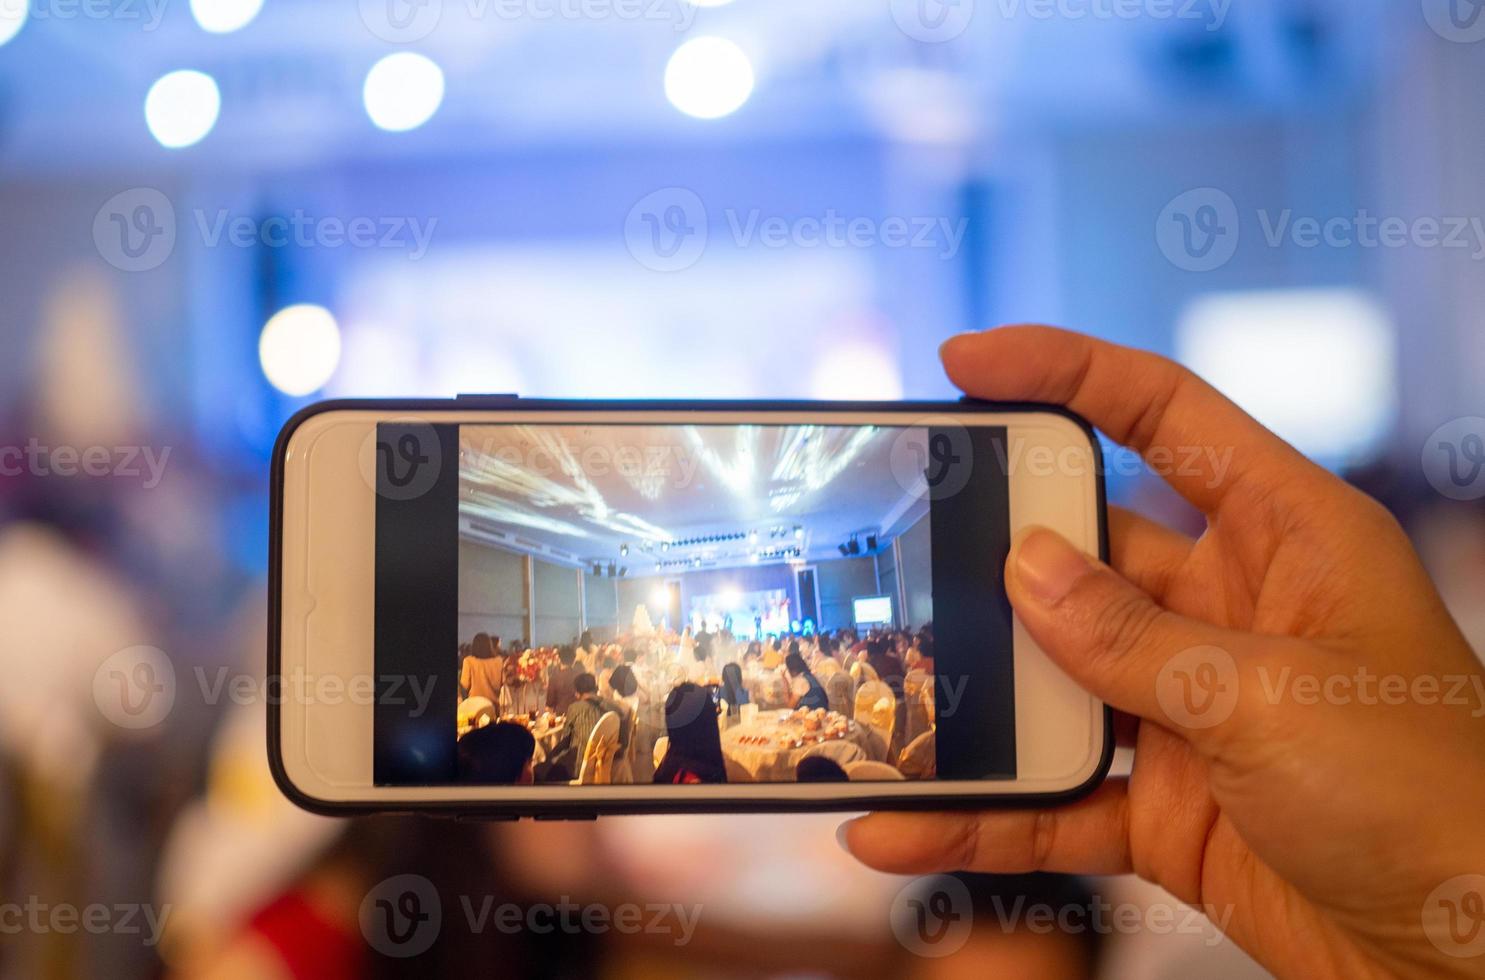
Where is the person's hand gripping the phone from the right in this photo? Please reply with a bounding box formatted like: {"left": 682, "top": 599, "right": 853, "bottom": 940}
{"left": 841, "top": 327, "right": 1485, "bottom": 977}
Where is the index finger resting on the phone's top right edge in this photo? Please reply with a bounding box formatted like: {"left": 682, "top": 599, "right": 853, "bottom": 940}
{"left": 940, "top": 327, "right": 1325, "bottom": 514}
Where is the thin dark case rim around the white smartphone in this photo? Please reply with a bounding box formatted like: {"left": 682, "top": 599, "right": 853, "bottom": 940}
{"left": 267, "top": 395, "right": 1114, "bottom": 820}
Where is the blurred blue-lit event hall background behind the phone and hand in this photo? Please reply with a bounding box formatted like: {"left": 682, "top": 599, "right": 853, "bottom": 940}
{"left": 0, "top": 0, "right": 1485, "bottom": 977}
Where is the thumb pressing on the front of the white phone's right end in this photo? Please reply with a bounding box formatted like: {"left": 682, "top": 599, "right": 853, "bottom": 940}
{"left": 1005, "top": 527, "right": 1247, "bottom": 747}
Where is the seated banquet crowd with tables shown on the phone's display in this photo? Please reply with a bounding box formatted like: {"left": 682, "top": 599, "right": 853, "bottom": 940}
{"left": 457, "top": 624, "right": 936, "bottom": 784}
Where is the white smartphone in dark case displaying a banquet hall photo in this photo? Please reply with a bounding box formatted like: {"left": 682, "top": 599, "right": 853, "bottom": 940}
{"left": 269, "top": 395, "right": 1112, "bottom": 818}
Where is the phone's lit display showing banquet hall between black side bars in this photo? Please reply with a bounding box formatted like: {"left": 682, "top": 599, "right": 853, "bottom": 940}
{"left": 373, "top": 422, "right": 1016, "bottom": 787}
